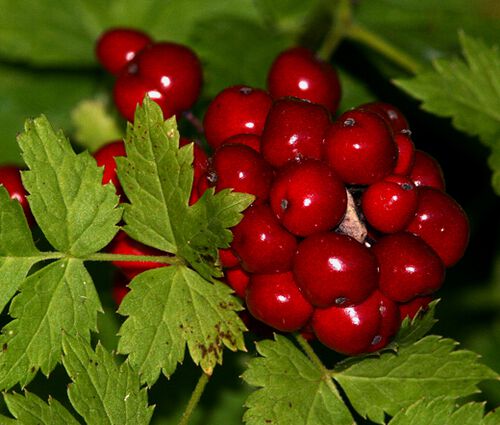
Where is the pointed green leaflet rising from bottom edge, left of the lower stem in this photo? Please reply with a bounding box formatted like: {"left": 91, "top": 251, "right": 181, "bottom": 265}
{"left": 63, "top": 334, "right": 154, "bottom": 425}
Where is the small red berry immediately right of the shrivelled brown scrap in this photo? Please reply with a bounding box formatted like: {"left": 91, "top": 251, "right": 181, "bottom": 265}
{"left": 361, "top": 175, "right": 417, "bottom": 233}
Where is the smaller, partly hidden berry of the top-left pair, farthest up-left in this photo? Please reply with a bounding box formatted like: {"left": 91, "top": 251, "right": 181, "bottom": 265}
{"left": 96, "top": 28, "right": 151, "bottom": 75}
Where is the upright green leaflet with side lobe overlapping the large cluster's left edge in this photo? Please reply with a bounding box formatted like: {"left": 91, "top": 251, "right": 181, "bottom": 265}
{"left": 116, "top": 98, "right": 253, "bottom": 278}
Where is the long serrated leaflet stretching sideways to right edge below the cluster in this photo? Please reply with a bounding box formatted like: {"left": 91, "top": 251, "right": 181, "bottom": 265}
{"left": 333, "top": 335, "right": 498, "bottom": 423}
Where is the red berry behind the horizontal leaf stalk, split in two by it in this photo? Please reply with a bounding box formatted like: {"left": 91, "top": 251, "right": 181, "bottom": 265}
{"left": 108, "top": 231, "right": 167, "bottom": 279}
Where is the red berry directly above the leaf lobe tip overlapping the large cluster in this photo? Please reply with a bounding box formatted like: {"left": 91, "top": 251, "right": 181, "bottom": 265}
{"left": 209, "top": 145, "right": 273, "bottom": 202}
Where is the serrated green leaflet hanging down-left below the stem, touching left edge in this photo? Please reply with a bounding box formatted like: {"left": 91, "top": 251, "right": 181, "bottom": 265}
{"left": 0, "top": 259, "right": 102, "bottom": 389}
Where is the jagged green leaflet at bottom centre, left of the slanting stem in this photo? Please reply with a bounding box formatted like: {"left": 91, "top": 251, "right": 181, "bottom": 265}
{"left": 243, "top": 335, "right": 354, "bottom": 425}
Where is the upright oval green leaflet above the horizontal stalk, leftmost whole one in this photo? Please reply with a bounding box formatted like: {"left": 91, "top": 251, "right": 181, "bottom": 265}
{"left": 19, "top": 116, "right": 121, "bottom": 257}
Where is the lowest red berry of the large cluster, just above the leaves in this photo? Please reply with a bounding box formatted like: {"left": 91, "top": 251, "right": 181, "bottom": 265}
{"left": 311, "top": 294, "right": 382, "bottom": 356}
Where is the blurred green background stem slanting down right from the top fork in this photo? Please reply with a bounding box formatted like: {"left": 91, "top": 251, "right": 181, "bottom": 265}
{"left": 345, "top": 24, "right": 422, "bottom": 74}
